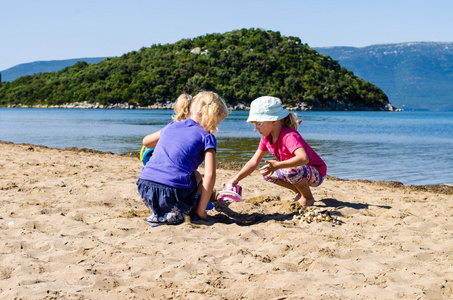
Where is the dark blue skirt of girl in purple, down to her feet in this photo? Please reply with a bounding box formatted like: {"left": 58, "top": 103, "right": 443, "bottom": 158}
{"left": 137, "top": 173, "right": 198, "bottom": 227}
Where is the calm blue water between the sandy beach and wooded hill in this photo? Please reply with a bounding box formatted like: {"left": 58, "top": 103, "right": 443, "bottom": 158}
{"left": 0, "top": 108, "right": 453, "bottom": 185}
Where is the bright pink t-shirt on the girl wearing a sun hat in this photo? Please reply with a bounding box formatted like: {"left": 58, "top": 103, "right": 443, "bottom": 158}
{"left": 258, "top": 126, "right": 327, "bottom": 176}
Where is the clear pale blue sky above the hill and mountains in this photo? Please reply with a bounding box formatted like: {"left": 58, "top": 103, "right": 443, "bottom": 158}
{"left": 0, "top": 0, "right": 453, "bottom": 71}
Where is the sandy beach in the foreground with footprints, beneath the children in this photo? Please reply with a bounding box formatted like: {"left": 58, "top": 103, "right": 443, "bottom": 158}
{"left": 0, "top": 142, "right": 453, "bottom": 299}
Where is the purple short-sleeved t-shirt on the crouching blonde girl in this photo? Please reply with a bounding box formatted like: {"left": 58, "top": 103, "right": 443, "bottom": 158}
{"left": 140, "top": 119, "right": 217, "bottom": 188}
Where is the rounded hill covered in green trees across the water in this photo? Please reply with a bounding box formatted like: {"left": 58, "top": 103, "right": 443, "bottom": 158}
{"left": 0, "top": 28, "right": 388, "bottom": 110}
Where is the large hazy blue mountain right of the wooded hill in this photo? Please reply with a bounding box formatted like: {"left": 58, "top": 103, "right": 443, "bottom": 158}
{"left": 314, "top": 42, "right": 453, "bottom": 110}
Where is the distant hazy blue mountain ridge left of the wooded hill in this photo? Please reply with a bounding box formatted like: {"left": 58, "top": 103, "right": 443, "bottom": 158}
{"left": 0, "top": 57, "right": 107, "bottom": 82}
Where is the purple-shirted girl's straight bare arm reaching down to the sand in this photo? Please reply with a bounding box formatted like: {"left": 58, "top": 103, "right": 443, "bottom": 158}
{"left": 197, "top": 149, "right": 216, "bottom": 220}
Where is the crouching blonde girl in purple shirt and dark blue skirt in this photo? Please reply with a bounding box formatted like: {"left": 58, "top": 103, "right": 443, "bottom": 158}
{"left": 137, "top": 91, "right": 229, "bottom": 226}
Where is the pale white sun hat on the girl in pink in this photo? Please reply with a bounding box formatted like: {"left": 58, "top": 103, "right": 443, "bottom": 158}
{"left": 247, "top": 96, "right": 289, "bottom": 122}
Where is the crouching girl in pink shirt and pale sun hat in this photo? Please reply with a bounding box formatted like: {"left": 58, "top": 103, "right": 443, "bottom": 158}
{"left": 225, "top": 96, "right": 327, "bottom": 206}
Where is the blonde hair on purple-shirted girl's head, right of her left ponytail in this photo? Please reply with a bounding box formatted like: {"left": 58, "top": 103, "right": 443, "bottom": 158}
{"left": 190, "top": 91, "right": 229, "bottom": 133}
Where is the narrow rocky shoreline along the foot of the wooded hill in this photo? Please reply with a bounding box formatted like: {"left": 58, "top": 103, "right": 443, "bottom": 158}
{"left": 7, "top": 101, "right": 401, "bottom": 111}
